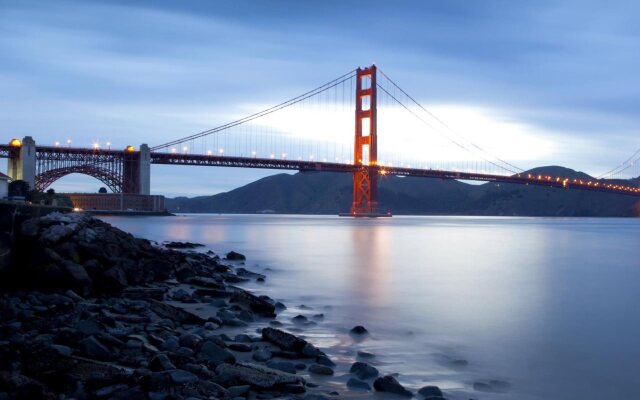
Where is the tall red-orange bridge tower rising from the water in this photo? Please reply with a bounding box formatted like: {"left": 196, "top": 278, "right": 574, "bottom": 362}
{"left": 351, "top": 65, "right": 378, "bottom": 216}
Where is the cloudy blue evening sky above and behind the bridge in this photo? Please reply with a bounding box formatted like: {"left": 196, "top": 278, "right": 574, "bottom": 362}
{"left": 0, "top": 0, "right": 640, "bottom": 197}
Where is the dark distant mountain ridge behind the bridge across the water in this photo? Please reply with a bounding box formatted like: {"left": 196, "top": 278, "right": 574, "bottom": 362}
{"left": 166, "top": 166, "right": 640, "bottom": 217}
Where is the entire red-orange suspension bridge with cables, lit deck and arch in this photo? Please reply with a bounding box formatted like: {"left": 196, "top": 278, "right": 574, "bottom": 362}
{"left": 0, "top": 65, "right": 640, "bottom": 216}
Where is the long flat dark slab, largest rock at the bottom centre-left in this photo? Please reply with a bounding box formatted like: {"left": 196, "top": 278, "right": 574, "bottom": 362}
{"left": 216, "top": 363, "right": 305, "bottom": 389}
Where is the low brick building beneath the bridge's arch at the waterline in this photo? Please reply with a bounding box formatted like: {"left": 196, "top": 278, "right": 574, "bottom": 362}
{"left": 64, "top": 193, "right": 165, "bottom": 212}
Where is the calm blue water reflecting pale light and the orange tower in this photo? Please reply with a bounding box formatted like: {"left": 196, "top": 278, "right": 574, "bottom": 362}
{"left": 100, "top": 215, "right": 640, "bottom": 400}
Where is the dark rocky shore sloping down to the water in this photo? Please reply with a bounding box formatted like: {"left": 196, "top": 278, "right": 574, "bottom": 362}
{"left": 0, "top": 213, "right": 443, "bottom": 400}
